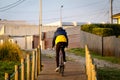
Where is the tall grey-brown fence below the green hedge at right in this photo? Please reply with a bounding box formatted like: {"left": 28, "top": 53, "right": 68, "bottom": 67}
{"left": 80, "top": 30, "right": 120, "bottom": 58}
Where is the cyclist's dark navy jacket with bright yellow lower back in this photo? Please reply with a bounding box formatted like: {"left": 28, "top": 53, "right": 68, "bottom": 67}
{"left": 52, "top": 27, "right": 68, "bottom": 47}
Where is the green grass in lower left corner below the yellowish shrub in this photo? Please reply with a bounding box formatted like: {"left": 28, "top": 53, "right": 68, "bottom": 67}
{"left": 0, "top": 61, "right": 20, "bottom": 80}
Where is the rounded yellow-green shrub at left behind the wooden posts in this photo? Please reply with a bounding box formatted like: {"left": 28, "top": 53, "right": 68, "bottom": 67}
{"left": 0, "top": 41, "right": 22, "bottom": 61}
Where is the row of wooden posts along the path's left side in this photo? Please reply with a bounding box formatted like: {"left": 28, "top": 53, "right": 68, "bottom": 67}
{"left": 5, "top": 46, "right": 42, "bottom": 80}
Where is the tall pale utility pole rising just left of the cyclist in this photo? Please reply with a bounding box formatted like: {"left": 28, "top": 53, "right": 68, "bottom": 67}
{"left": 39, "top": 0, "right": 42, "bottom": 45}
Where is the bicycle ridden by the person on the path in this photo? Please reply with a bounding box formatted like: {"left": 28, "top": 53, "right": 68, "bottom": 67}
{"left": 59, "top": 46, "right": 65, "bottom": 76}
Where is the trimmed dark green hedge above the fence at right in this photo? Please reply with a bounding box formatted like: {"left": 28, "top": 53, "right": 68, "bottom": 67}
{"left": 81, "top": 24, "right": 120, "bottom": 37}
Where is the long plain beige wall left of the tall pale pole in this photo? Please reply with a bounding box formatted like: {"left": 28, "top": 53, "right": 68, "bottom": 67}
{"left": 5, "top": 25, "right": 39, "bottom": 36}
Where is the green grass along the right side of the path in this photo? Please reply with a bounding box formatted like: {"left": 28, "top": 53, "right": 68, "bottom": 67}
{"left": 67, "top": 48, "right": 120, "bottom": 80}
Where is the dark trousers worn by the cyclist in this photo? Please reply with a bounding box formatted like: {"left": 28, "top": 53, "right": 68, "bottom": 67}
{"left": 56, "top": 42, "right": 66, "bottom": 67}
